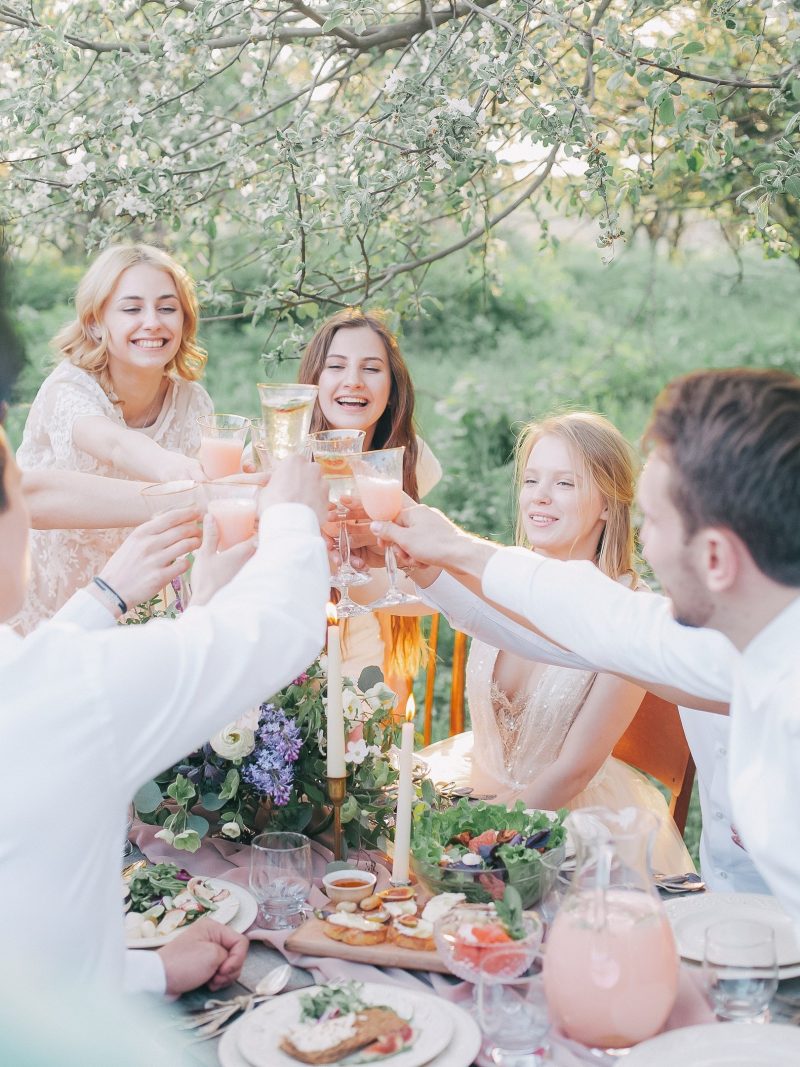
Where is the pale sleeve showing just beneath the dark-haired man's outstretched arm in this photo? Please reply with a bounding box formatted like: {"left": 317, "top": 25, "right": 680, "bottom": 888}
{"left": 417, "top": 571, "right": 595, "bottom": 670}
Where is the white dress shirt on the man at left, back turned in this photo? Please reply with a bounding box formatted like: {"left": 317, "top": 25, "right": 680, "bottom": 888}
{"left": 0, "top": 504, "right": 330, "bottom": 989}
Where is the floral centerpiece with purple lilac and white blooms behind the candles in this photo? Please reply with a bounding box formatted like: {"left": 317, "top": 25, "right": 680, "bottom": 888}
{"left": 134, "top": 655, "right": 407, "bottom": 851}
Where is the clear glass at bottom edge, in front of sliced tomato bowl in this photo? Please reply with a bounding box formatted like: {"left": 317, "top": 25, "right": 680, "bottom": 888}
{"left": 478, "top": 943, "right": 549, "bottom": 1067}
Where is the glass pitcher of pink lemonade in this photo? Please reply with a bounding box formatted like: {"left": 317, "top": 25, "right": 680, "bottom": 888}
{"left": 543, "top": 808, "right": 678, "bottom": 1053}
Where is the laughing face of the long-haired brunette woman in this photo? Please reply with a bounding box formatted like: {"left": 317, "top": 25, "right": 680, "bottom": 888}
{"left": 318, "top": 327, "right": 391, "bottom": 451}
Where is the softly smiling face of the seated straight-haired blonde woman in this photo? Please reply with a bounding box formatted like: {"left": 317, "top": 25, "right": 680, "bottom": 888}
{"left": 519, "top": 433, "right": 608, "bottom": 559}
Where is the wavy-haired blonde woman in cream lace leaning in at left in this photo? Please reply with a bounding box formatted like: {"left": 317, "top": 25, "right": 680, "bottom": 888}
{"left": 15, "top": 244, "right": 213, "bottom": 633}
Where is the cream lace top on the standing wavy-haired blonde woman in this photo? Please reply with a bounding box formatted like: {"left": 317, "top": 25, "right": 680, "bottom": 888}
{"left": 14, "top": 360, "right": 213, "bottom": 634}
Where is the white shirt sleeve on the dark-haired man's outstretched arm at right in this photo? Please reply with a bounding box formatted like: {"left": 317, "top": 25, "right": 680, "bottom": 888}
{"left": 482, "top": 548, "right": 737, "bottom": 701}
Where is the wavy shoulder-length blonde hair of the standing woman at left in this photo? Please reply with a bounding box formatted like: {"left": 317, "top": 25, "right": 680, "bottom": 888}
{"left": 52, "top": 244, "right": 208, "bottom": 401}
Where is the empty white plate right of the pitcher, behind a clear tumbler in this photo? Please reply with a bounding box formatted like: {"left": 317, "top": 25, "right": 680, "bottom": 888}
{"left": 663, "top": 893, "right": 800, "bottom": 977}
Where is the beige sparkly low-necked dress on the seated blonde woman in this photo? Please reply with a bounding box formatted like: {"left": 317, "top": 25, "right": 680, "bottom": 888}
{"left": 420, "top": 639, "right": 694, "bottom": 873}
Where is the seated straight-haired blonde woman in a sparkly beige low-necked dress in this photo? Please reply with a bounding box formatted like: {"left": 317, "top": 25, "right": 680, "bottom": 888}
{"left": 417, "top": 412, "right": 692, "bottom": 872}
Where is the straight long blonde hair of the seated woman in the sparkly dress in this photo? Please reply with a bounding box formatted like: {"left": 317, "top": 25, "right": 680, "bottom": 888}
{"left": 514, "top": 411, "right": 637, "bottom": 579}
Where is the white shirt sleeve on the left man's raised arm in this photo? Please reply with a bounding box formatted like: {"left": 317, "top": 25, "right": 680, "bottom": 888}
{"left": 50, "top": 504, "right": 330, "bottom": 796}
